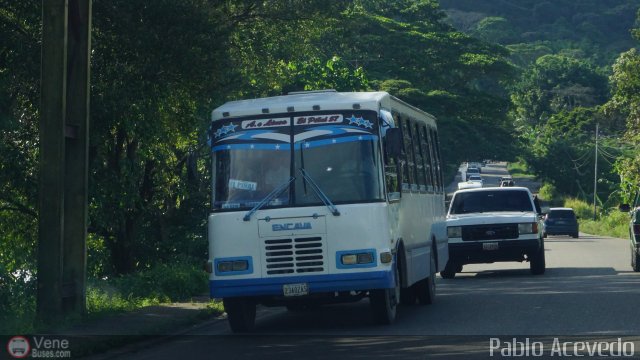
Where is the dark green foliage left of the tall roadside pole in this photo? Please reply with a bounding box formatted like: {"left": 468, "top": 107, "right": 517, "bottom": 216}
{"left": 0, "top": 1, "right": 41, "bottom": 323}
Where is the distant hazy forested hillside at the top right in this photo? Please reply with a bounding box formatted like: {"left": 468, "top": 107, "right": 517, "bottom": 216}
{"left": 440, "top": 0, "right": 640, "bottom": 66}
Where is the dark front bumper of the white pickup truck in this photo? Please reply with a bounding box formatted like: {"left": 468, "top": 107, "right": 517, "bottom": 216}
{"left": 449, "top": 239, "right": 542, "bottom": 265}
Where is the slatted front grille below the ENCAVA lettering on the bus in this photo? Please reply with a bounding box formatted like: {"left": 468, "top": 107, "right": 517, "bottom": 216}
{"left": 264, "top": 237, "right": 325, "bottom": 275}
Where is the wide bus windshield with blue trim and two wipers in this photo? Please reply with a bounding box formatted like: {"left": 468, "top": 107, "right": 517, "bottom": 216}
{"left": 212, "top": 111, "right": 384, "bottom": 210}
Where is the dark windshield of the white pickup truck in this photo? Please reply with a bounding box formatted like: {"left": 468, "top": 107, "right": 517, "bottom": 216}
{"left": 450, "top": 191, "right": 535, "bottom": 214}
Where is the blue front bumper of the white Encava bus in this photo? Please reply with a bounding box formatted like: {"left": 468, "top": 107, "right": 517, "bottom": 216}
{"left": 209, "top": 270, "right": 395, "bottom": 298}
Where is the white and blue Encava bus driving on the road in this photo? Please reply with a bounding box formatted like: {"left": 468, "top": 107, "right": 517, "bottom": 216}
{"left": 208, "top": 91, "right": 448, "bottom": 332}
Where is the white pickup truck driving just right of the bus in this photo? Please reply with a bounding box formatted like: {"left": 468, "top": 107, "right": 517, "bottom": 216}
{"left": 440, "top": 187, "right": 545, "bottom": 279}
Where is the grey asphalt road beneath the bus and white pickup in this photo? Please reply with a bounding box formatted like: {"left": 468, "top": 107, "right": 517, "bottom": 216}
{"left": 96, "top": 164, "right": 640, "bottom": 359}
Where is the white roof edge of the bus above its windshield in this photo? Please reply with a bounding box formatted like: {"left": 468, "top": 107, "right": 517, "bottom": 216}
{"left": 211, "top": 90, "right": 432, "bottom": 121}
